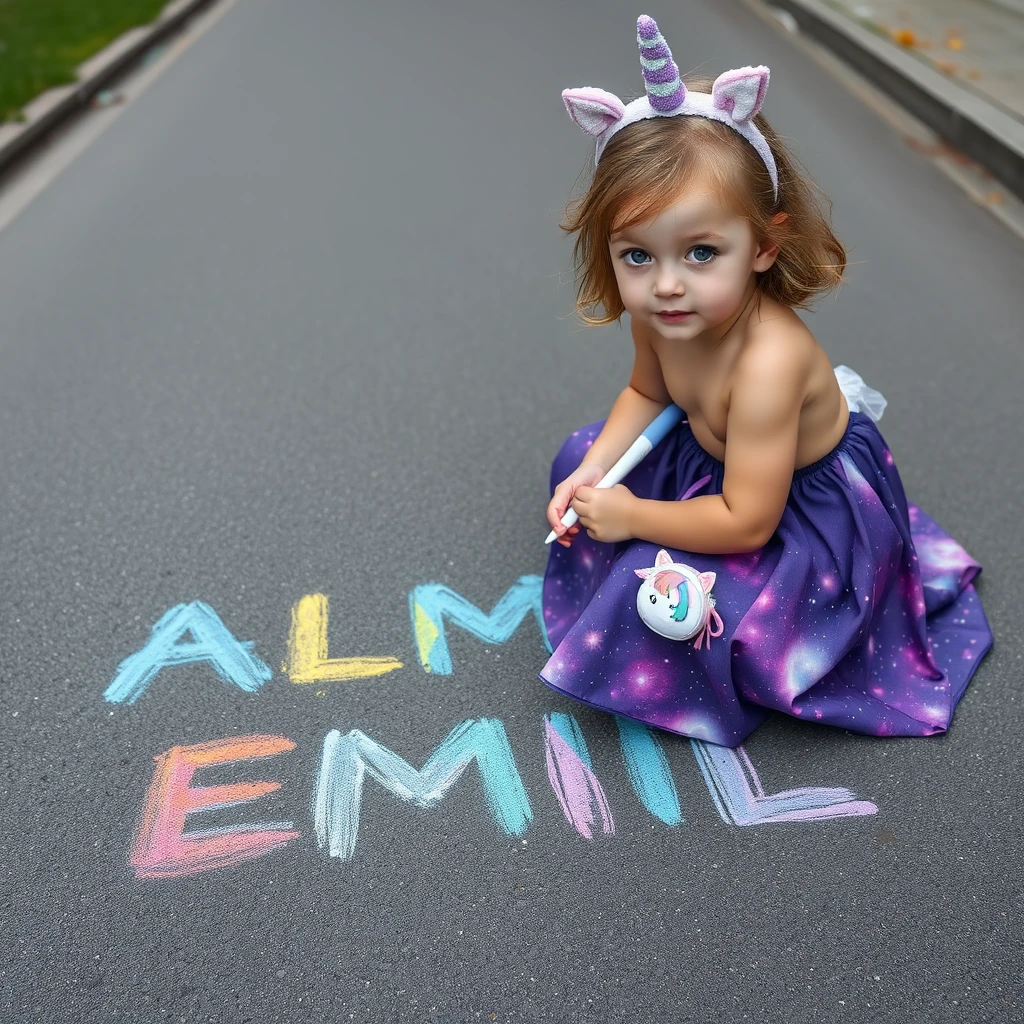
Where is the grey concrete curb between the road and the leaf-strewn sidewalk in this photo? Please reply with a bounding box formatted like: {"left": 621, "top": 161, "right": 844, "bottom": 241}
{"left": 766, "top": 0, "right": 1024, "bottom": 200}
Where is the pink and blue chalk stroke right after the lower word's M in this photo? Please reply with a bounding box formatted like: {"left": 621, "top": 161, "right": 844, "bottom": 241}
{"left": 544, "top": 712, "right": 615, "bottom": 839}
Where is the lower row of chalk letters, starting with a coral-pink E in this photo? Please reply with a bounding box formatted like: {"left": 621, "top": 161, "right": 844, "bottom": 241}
{"left": 130, "top": 712, "right": 878, "bottom": 879}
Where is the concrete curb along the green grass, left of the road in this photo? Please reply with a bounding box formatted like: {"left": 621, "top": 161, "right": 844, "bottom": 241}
{"left": 0, "top": 0, "right": 214, "bottom": 173}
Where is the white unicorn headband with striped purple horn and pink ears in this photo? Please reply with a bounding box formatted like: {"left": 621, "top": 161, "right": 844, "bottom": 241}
{"left": 562, "top": 14, "right": 778, "bottom": 199}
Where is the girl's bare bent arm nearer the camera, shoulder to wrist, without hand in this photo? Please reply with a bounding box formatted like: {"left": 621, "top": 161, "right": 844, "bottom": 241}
{"left": 630, "top": 344, "right": 807, "bottom": 554}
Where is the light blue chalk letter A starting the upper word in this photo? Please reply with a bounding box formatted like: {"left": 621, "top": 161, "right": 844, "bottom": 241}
{"left": 103, "top": 601, "right": 272, "bottom": 703}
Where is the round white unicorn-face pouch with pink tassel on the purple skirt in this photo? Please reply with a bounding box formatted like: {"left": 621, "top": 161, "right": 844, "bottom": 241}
{"left": 633, "top": 548, "right": 725, "bottom": 650}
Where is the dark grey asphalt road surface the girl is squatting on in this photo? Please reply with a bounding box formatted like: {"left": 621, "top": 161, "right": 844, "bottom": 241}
{"left": 0, "top": 0, "right": 1024, "bottom": 1024}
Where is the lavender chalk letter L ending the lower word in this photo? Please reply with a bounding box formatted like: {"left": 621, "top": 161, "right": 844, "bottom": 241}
{"left": 690, "top": 739, "right": 879, "bottom": 825}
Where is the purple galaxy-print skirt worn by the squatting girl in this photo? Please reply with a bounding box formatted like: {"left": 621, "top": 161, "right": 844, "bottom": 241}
{"left": 541, "top": 413, "right": 992, "bottom": 746}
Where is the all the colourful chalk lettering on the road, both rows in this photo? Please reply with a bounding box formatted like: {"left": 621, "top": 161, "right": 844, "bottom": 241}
{"left": 110, "top": 575, "right": 878, "bottom": 879}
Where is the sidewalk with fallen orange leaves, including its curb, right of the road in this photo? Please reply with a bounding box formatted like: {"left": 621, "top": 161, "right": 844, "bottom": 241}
{"left": 764, "top": 0, "right": 1024, "bottom": 199}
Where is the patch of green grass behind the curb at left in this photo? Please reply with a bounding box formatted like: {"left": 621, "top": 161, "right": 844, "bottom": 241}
{"left": 0, "top": 0, "right": 167, "bottom": 121}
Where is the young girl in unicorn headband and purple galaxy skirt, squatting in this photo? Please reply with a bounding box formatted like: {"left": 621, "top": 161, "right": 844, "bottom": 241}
{"left": 541, "top": 16, "right": 992, "bottom": 746}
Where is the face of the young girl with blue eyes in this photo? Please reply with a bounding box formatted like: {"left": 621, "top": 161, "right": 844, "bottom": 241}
{"left": 608, "top": 185, "right": 778, "bottom": 342}
